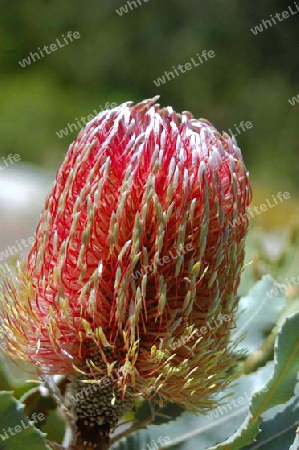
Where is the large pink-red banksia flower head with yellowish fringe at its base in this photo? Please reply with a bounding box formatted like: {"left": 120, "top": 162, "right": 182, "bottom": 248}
{"left": 1, "top": 98, "right": 250, "bottom": 446}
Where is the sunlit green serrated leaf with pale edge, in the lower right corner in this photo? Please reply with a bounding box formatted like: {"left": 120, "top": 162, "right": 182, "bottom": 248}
{"left": 209, "top": 313, "right": 299, "bottom": 450}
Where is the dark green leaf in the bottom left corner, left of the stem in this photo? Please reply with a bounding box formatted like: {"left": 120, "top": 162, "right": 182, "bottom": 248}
{"left": 0, "top": 391, "right": 49, "bottom": 450}
